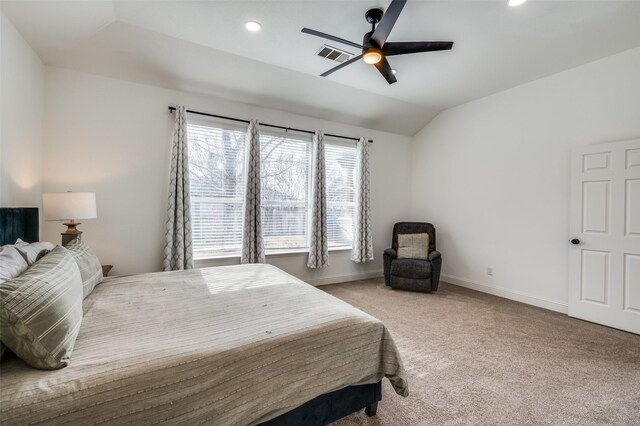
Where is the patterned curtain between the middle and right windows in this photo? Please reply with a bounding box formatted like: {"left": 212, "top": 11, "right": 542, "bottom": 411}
{"left": 307, "top": 131, "right": 329, "bottom": 268}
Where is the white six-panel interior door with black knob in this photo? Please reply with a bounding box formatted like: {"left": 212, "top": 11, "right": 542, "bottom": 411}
{"left": 569, "top": 139, "right": 640, "bottom": 334}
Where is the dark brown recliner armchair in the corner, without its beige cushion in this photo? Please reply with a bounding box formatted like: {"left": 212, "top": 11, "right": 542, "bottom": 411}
{"left": 383, "top": 222, "right": 442, "bottom": 292}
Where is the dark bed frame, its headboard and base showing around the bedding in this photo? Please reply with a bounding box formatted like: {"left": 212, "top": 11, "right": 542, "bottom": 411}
{"left": 0, "top": 207, "right": 382, "bottom": 426}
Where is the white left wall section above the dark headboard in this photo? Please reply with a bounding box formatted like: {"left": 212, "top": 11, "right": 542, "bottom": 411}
{"left": 0, "top": 13, "right": 44, "bottom": 207}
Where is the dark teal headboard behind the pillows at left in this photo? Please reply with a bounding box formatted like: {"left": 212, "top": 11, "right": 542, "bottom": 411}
{"left": 0, "top": 207, "right": 40, "bottom": 245}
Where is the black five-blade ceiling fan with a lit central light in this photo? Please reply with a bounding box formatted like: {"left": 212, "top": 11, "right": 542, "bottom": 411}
{"left": 302, "top": 0, "right": 453, "bottom": 84}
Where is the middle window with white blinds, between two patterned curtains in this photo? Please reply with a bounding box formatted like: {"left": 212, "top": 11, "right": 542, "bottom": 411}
{"left": 260, "top": 134, "right": 311, "bottom": 252}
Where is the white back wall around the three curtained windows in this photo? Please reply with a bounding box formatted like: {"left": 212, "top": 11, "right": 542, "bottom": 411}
{"left": 43, "top": 67, "right": 411, "bottom": 284}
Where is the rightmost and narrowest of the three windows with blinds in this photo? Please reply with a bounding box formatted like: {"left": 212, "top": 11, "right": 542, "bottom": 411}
{"left": 324, "top": 141, "right": 356, "bottom": 248}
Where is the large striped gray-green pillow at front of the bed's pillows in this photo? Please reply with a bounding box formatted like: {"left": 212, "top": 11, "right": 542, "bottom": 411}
{"left": 0, "top": 247, "right": 82, "bottom": 370}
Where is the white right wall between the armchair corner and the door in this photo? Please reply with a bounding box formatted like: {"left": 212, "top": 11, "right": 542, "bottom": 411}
{"left": 412, "top": 48, "right": 640, "bottom": 311}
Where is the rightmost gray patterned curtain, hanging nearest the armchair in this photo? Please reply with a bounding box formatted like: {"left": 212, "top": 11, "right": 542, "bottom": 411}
{"left": 351, "top": 138, "right": 373, "bottom": 263}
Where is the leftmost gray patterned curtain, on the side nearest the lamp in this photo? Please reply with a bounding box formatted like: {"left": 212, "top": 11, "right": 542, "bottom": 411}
{"left": 163, "top": 106, "right": 193, "bottom": 271}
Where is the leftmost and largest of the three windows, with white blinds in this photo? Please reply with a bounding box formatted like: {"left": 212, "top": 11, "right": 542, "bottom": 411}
{"left": 187, "top": 123, "right": 246, "bottom": 258}
